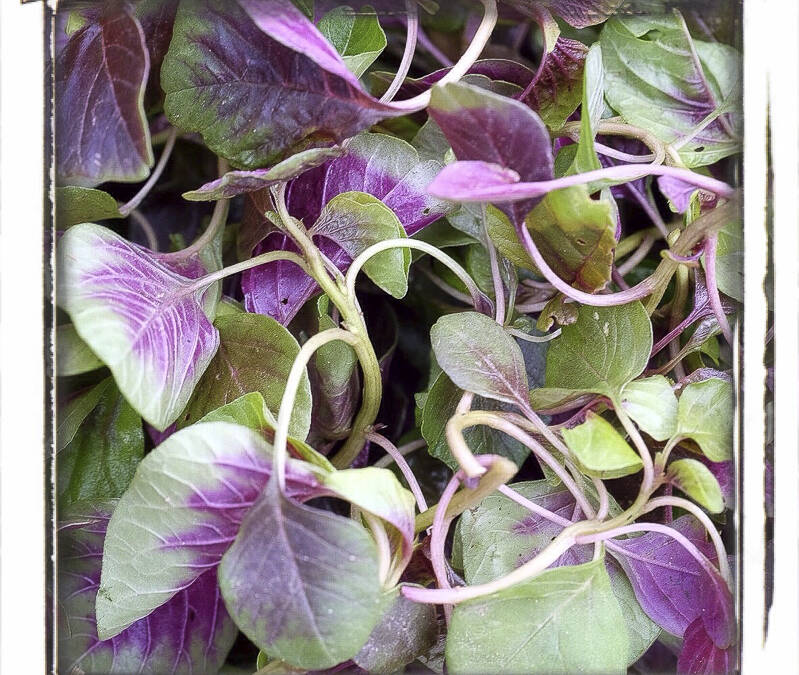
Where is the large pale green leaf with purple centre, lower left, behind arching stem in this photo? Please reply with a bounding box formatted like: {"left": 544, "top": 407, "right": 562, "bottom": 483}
{"left": 97, "top": 422, "right": 323, "bottom": 639}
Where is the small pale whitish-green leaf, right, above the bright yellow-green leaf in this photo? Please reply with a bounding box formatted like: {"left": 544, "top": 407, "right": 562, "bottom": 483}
{"left": 621, "top": 375, "right": 677, "bottom": 441}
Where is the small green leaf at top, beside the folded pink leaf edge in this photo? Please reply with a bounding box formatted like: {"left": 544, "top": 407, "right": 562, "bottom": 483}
{"left": 317, "top": 5, "right": 387, "bottom": 77}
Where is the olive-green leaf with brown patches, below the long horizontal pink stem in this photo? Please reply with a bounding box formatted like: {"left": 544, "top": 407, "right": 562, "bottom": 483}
{"left": 525, "top": 185, "right": 616, "bottom": 293}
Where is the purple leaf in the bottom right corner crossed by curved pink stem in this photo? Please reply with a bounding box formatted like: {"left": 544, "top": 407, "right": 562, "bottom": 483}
{"left": 613, "top": 516, "right": 735, "bottom": 647}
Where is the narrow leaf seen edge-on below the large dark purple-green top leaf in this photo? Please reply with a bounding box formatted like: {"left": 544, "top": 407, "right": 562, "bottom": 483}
{"left": 183, "top": 147, "right": 342, "bottom": 201}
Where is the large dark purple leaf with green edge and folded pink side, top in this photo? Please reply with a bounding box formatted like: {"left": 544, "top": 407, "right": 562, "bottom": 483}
{"left": 161, "top": 0, "right": 401, "bottom": 169}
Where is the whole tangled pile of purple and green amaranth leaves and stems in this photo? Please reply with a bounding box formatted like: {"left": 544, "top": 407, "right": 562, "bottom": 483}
{"left": 53, "top": 0, "right": 742, "bottom": 675}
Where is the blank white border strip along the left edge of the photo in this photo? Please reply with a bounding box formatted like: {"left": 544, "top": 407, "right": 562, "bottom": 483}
{"left": 0, "top": 0, "right": 49, "bottom": 674}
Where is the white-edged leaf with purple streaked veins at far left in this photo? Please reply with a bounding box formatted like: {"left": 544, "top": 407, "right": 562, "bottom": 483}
{"left": 57, "top": 224, "right": 219, "bottom": 431}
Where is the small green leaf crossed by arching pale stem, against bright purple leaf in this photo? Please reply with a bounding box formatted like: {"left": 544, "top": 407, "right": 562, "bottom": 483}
{"left": 309, "top": 192, "right": 411, "bottom": 298}
